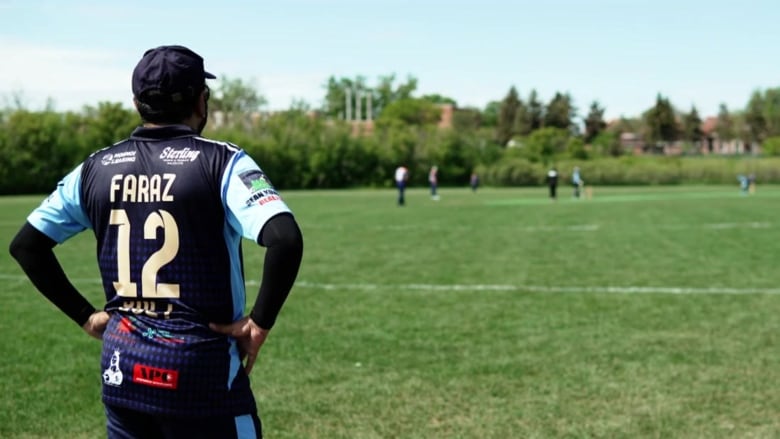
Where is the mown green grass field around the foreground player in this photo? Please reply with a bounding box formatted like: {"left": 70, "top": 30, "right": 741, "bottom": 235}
{"left": 0, "top": 186, "right": 780, "bottom": 439}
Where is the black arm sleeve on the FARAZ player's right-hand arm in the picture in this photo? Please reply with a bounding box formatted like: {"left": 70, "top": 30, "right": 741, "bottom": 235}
{"left": 250, "top": 214, "right": 303, "bottom": 329}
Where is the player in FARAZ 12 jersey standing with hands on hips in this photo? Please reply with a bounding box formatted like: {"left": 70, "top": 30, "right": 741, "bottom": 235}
{"left": 10, "top": 46, "right": 303, "bottom": 439}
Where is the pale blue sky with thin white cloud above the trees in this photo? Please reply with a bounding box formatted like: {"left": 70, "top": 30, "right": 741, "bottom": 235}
{"left": 0, "top": 0, "right": 780, "bottom": 118}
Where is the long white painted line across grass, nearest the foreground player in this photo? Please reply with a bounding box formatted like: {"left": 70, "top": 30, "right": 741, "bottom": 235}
{"left": 0, "top": 273, "right": 780, "bottom": 295}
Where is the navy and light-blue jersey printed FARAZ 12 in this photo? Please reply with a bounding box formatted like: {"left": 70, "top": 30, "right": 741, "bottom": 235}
{"left": 28, "top": 125, "right": 290, "bottom": 416}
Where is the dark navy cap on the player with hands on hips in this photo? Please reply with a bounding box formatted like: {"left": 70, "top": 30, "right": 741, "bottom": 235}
{"left": 133, "top": 46, "right": 216, "bottom": 103}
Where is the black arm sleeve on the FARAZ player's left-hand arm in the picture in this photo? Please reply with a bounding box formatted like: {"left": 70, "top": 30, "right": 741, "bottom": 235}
{"left": 9, "top": 223, "right": 95, "bottom": 326}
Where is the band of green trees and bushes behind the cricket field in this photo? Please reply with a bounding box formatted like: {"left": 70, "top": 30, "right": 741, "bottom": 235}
{"left": 0, "top": 75, "right": 780, "bottom": 194}
